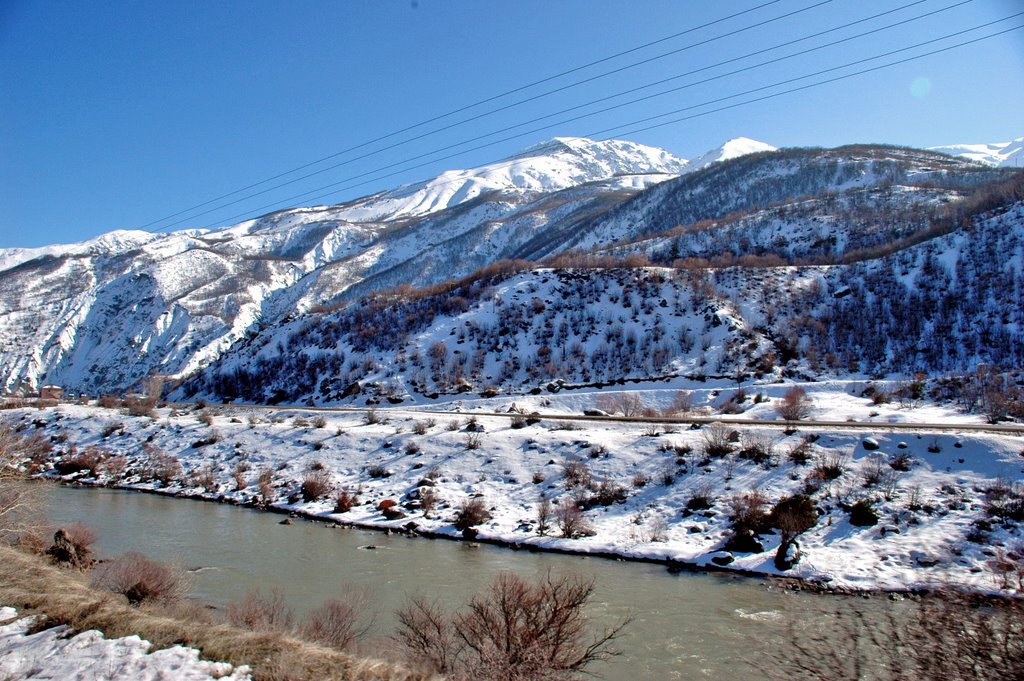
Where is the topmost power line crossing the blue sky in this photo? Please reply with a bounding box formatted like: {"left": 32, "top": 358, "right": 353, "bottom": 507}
{"left": 139, "top": 0, "right": 790, "bottom": 229}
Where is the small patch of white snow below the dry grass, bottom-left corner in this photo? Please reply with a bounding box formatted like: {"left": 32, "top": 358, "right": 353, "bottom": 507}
{"left": 0, "top": 606, "right": 251, "bottom": 681}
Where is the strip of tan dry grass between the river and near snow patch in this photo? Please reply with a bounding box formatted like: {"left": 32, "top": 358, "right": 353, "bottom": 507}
{"left": 0, "top": 546, "right": 437, "bottom": 681}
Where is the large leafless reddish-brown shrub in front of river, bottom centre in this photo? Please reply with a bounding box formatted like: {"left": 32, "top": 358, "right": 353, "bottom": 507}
{"left": 395, "top": 572, "right": 629, "bottom": 681}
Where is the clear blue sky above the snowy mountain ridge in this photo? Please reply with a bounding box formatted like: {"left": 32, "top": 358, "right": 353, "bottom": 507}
{"left": 0, "top": 0, "right": 1024, "bottom": 248}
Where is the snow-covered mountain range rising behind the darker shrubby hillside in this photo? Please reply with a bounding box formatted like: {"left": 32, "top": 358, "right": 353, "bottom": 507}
{"left": 0, "top": 138, "right": 1015, "bottom": 399}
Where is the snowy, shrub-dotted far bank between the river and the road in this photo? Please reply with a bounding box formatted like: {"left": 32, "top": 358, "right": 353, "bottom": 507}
{"left": 6, "top": 385, "right": 1024, "bottom": 591}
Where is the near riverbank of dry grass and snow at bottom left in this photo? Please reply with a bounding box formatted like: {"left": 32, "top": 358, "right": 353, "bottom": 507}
{"left": 0, "top": 545, "right": 425, "bottom": 681}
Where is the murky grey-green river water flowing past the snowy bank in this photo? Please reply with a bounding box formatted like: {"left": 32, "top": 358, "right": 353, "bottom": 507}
{"left": 41, "top": 486, "right": 872, "bottom": 681}
